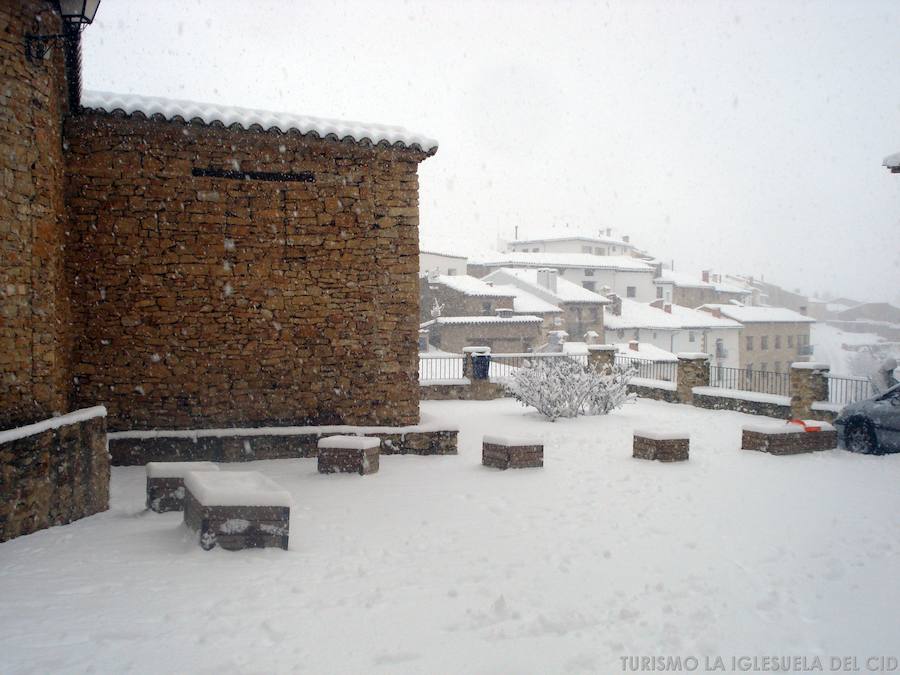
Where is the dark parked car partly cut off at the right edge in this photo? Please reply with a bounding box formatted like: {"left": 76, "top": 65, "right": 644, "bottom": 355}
{"left": 834, "top": 385, "right": 900, "bottom": 454}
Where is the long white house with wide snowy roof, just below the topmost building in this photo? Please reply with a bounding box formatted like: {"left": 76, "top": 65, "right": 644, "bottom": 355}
{"left": 469, "top": 252, "right": 657, "bottom": 302}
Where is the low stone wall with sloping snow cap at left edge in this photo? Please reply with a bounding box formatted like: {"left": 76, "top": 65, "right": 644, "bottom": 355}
{"left": 0, "top": 407, "right": 109, "bottom": 541}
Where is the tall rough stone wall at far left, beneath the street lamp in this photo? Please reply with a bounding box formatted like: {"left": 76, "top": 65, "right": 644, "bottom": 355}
{"left": 0, "top": 0, "right": 71, "bottom": 429}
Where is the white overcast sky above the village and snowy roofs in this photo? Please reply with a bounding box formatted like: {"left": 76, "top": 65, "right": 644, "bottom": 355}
{"left": 84, "top": 0, "right": 900, "bottom": 303}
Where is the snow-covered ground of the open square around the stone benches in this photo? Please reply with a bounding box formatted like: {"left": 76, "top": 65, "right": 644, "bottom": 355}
{"left": 0, "top": 399, "right": 900, "bottom": 674}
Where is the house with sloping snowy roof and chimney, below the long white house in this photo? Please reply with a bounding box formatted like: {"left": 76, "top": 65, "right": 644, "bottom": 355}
{"left": 484, "top": 267, "right": 609, "bottom": 340}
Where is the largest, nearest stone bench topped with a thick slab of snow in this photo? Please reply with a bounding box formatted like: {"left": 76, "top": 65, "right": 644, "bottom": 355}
{"left": 184, "top": 471, "right": 291, "bottom": 551}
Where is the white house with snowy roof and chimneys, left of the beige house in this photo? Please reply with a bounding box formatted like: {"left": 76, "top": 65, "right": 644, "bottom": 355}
{"left": 604, "top": 297, "right": 741, "bottom": 368}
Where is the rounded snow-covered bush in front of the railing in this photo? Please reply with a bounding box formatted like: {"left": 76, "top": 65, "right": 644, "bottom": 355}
{"left": 506, "top": 358, "right": 634, "bottom": 422}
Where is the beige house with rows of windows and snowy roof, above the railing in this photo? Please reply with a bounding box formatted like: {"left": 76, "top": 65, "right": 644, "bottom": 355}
{"left": 699, "top": 304, "right": 815, "bottom": 373}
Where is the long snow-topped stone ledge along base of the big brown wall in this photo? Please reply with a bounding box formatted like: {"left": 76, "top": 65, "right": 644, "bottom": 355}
{"left": 109, "top": 426, "right": 458, "bottom": 466}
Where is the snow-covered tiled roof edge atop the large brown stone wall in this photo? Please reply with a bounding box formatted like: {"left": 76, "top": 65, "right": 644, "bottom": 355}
{"left": 81, "top": 91, "right": 438, "bottom": 154}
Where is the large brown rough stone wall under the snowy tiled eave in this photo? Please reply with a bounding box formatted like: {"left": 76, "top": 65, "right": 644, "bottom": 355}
{"left": 66, "top": 113, "right": 425, "bottom": 429}
